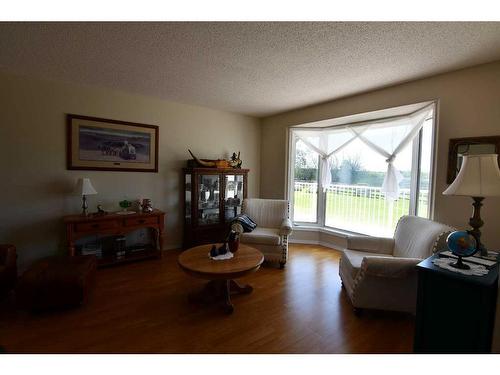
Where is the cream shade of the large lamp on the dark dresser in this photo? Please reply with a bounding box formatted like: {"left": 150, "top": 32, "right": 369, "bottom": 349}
{"left": 443, "top": 154, "right": 500, "bottom": 197}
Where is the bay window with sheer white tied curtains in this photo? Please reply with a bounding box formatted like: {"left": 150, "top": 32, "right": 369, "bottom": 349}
{"left": 289, "top": 103, "right": 435, "bottom": 236}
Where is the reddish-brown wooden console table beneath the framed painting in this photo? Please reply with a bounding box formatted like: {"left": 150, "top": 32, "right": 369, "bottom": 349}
{"left": 63, "top": 210, "right": 165, "bottom": 266}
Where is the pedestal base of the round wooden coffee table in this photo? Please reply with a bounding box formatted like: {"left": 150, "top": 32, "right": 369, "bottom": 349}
{"left": 190, "top": 280, "right": 253, "bottom": 314}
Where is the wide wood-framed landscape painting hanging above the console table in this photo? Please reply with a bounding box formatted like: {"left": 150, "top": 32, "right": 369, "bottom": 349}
{"left": 67, "top": 114, "right": 158, "bottom": 172}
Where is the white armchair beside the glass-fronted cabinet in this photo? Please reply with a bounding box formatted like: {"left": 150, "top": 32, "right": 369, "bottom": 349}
{"left": 232, "top": 198, "right": 292, "bottom": 268}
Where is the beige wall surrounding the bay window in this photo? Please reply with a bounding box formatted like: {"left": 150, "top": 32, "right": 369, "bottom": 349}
{"left": 260, "top": 62, "right": 500, "bottom": 249}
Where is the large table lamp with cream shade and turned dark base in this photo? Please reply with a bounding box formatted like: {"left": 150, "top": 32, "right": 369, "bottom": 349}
{"left": 443, "top": 154, "right": 500, "bottom": 256}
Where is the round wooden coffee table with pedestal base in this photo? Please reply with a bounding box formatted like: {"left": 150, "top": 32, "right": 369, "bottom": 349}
{"left": 177, "top": 244, "right": 264, "bottom": 314}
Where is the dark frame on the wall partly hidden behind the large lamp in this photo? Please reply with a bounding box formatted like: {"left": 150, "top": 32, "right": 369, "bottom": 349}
{"left": 446, "top": 135, "right": 500, "bottom": 184}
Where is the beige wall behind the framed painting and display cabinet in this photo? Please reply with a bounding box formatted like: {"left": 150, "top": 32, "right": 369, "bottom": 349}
{"left": 0, "top": 72, "right": 260, "bottom": 268}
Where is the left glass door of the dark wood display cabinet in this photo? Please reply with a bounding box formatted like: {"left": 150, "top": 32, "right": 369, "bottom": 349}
{"left": 198, "top": 174, "right": 220, "bottom": 225}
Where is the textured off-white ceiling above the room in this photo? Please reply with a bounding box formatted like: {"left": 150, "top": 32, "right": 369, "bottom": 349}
{"left": 0, "top": 22, "right": 500, "bottom": 116}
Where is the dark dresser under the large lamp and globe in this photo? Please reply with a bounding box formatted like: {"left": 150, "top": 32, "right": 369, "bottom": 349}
{"left": 414, "top": 255, "right": 498, "bottom": 353}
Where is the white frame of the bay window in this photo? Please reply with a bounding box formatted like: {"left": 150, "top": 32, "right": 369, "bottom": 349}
{"left": 286, "top": 101, "right": 438, "bottom": 236}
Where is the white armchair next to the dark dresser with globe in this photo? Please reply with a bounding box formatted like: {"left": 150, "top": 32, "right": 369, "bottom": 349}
{"left": 339, "top": 216, "right": 454, "bottom": 313}
